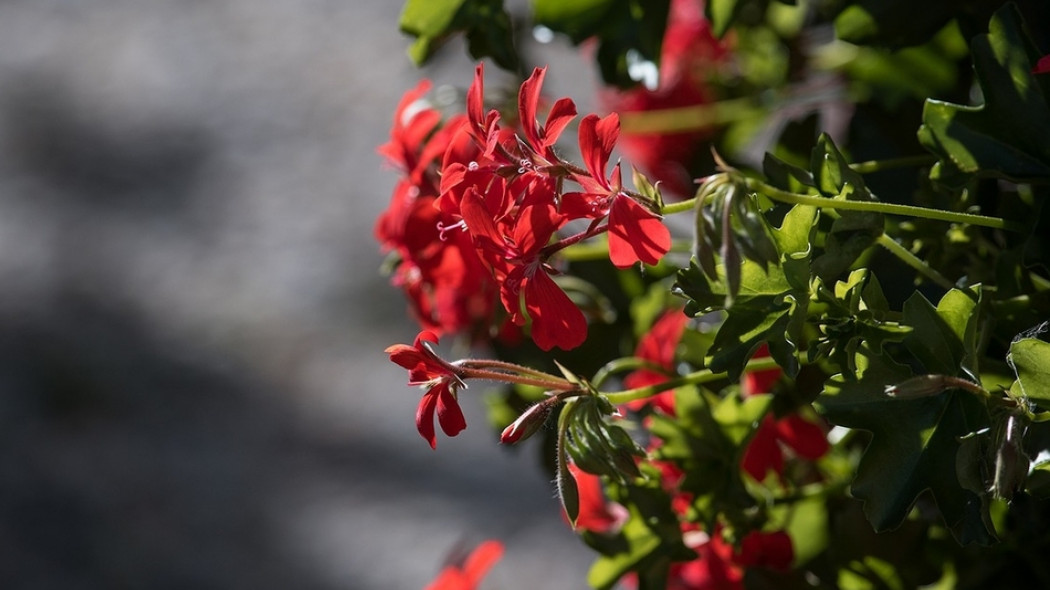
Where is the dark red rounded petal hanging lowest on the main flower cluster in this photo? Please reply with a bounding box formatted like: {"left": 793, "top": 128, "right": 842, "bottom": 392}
{"left": 525, "top": 270, "right": 587, "bottom": 351}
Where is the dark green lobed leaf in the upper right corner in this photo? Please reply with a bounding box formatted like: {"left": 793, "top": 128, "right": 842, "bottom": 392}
{"left": 919, "top": 5, "right": 1050, "bottom": 187}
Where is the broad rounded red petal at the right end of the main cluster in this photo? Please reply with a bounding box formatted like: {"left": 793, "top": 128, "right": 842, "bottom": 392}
{"left": 609, "top": 195, "right": 671, "bottom": 269}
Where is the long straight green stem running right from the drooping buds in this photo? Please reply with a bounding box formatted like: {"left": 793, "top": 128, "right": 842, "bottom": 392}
{"left": 741, "top": 177, "right": 1023, "bottom": 232}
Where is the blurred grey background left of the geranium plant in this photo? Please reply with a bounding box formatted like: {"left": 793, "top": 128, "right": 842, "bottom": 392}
{"left": 0, "top": 0, "right": 594, "bottom": 590}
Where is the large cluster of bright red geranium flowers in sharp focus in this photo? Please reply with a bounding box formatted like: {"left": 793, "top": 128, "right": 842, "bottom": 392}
{"left": 376, "top": 65, "right": 671, "bottom": 351}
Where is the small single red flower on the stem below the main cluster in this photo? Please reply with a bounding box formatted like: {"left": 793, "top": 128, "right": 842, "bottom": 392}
{"left": 385, "top": 332, "right": 466, "bottom": 448}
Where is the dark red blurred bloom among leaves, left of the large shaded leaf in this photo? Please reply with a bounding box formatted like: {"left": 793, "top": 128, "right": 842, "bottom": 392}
{"left": 741, "top": 344, "right": 831, "bottom": 481}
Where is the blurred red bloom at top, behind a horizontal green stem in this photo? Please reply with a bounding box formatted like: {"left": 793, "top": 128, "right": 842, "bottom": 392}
{"left": 603, "top": 0, "right": 729, "bottom": 196}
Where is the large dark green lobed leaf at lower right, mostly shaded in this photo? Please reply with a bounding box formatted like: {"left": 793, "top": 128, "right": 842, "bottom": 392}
{"left": 817, "top": 346, "right": 994, "bottom": 545}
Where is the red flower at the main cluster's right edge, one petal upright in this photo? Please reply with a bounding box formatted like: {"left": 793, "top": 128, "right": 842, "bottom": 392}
{"left": 562, "top": 113, "right": 671, "bottom": 269}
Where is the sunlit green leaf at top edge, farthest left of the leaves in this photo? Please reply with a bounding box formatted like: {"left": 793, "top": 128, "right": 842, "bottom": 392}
{"left": 400, "top": 0, "right": 518, "bottom": 69}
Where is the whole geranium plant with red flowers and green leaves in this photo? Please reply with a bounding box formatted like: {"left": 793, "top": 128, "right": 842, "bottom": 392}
{"left": 376, "top": 0, "right": 1050, "bottom": 588}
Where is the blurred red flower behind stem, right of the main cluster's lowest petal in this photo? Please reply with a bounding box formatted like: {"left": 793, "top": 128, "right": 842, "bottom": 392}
{"left": 624, "top": 309, "right": 689, "bottom": 416}
